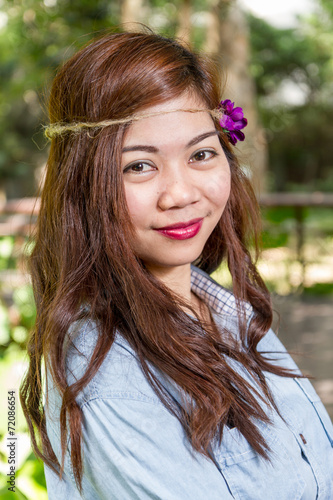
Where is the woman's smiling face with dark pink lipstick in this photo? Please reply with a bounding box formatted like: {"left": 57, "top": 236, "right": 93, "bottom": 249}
{"left": 122, "top": 95, "right": 230, "bottom": 274}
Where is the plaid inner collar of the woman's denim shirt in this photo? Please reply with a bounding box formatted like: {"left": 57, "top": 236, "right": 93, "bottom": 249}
{"left": 191, "top": 266, "right": 252, "bottom": 316}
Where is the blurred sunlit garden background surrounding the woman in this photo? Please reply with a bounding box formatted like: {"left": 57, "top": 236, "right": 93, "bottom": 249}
{"left": 0, "top": 0, "right": 333, "bottom": 500}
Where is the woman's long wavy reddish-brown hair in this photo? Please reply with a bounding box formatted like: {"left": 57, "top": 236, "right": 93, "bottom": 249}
{"left": 21, "top": 33, "right": 290, "bottom": 489}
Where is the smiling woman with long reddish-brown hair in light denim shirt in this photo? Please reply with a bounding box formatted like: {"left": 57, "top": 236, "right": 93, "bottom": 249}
{"left": 21, "top": 33, "right": 333, "bottom": 500}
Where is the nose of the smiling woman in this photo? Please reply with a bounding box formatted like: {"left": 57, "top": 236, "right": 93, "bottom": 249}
{"left": 158, "top": 168, "right": 200, "bottom": 210}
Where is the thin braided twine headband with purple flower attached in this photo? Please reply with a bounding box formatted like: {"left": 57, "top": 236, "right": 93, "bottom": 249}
{"left": 44, "top": 99, "right": 247, "bottom": 145}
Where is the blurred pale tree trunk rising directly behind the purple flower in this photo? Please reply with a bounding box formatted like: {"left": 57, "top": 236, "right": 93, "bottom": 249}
{"left": 204, "top": 0, "right": 267, "bottom": 192}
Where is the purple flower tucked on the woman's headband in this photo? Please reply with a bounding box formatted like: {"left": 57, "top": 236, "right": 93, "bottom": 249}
{"left": 217, "top": 99, "right": 247, "bottom": 146}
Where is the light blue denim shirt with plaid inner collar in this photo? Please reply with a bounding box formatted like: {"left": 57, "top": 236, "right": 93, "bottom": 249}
{"left": 45, "top": 267, "right": 333, "bottom": 500}
